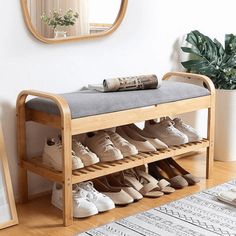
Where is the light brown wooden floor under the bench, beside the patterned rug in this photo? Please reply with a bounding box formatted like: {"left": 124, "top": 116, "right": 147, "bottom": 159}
{"left": 0, "top": 153, "right": 236, "bottom": 236}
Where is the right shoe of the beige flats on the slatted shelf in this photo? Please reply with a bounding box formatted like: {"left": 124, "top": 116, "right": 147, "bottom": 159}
{"left": 128, "top": 124, "right": 168, "bottom": 149}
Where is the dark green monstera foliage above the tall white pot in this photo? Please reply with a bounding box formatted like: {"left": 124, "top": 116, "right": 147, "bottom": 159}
{"left": 181, "top": 30, "right": 236, "bottom": 89}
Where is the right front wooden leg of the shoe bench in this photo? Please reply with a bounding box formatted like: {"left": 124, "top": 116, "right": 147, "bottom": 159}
{"left": 206, "top": 102, "right": 215, "bottom": 179}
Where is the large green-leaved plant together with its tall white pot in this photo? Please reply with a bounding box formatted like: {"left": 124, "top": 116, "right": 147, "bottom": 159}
{"left": 181, "top": 31, "right": 236, "bottom": 161}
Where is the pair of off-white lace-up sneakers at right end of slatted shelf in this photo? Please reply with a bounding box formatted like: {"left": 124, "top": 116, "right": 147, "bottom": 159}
{"left": 144, "top": 117, "right": 201, "bottom": 146}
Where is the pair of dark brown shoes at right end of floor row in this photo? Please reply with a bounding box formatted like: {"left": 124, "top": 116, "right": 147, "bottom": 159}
{"left": 148, "top": 158, "right": 200, "bottom": 189}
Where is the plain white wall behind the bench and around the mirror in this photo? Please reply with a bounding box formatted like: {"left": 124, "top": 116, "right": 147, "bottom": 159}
{"left": 0, "top": 0, "right": 236, "bottom": 199}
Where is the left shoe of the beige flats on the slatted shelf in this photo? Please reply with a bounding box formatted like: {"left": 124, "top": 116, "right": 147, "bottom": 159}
{"left": 116, "top": 126, "right": 156, "bottom": 152}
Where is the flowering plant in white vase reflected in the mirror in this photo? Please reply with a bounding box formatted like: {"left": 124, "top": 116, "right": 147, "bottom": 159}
{"left": 41, "top": 9, "right": 79, "bottom": 38}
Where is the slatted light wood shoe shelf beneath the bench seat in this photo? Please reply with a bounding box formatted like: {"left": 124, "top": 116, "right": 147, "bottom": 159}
{"left": 23, "top": 139, "right": 209, "bottom": 184}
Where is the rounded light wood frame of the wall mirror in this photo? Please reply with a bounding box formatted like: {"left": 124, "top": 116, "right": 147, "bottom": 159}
{"left": 20, "top": 0, "right": 128, "bottom": 43}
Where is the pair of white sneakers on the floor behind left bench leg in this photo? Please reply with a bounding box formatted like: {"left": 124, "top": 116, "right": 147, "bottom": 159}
{"left": 51, "top": 181, "right": 115, "bottom": 218}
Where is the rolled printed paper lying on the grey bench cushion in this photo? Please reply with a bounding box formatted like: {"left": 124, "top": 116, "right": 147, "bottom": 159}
{"left": 103, "top": 75, "right": 161, "bottom": 92}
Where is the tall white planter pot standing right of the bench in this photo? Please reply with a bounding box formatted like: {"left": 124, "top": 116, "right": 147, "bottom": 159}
{"left": 215, "top": 89, "right": 236, "bottom": 161}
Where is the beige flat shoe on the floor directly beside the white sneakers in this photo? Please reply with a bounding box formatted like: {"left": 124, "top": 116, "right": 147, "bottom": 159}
{"left": 93, "top": 177, "right": 134, "bottom": 205}
